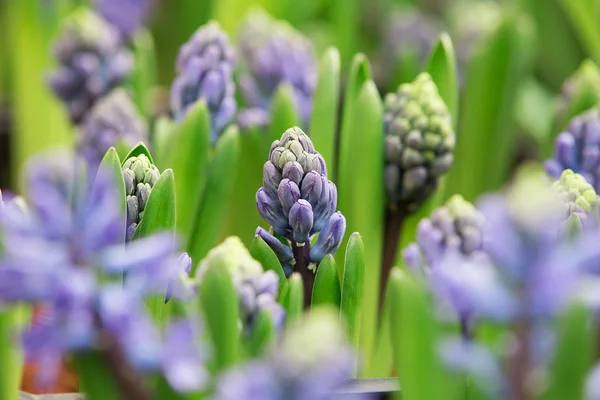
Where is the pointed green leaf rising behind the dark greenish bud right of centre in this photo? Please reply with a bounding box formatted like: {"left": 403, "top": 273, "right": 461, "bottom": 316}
{"left": 427, "top": 32, "right": 458, "bottom": 126}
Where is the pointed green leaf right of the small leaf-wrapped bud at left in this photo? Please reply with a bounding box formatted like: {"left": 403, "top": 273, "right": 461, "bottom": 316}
{"left": 134, "top": 169, "right": 176, "bottom": 239}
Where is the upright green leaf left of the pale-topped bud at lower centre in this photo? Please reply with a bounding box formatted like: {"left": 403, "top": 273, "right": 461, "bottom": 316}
{"left": 198, "top": 258, "right": 240, "bottom": 371}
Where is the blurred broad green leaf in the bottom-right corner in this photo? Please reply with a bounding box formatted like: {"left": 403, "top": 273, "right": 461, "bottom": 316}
{"left": 542, "top": 305, "right": 596, "bottom": 400}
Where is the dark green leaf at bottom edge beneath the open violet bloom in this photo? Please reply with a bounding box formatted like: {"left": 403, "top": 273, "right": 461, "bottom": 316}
{"left": 73, "top": 351, "right": 126, "bottom": 400}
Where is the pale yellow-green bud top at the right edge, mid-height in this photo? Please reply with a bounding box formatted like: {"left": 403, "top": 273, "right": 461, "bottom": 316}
{"left": 552, "top": 169, "right": 600, "bottom": 225}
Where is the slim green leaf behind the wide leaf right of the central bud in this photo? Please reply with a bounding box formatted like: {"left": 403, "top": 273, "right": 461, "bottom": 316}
{"left": 338, "top": 53, "right": 370, "bottom": 186}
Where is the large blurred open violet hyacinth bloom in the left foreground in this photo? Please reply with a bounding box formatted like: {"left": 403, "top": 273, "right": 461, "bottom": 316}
{"left": 0, "top": 154, "right": 206, "bottom": 390}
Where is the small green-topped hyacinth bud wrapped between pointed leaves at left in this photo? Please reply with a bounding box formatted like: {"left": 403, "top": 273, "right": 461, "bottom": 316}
{"left": 122, "top": 154, "right": 160, "bottom": 241}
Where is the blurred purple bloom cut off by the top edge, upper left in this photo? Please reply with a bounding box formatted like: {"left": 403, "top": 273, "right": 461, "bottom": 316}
{"left": 95, "top": 0, "right": 154, "bottom": 40}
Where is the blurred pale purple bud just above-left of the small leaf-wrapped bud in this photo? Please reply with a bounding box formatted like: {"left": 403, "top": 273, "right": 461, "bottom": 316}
{"left": 77, "top": 89, "right": 148, "bottom": 168}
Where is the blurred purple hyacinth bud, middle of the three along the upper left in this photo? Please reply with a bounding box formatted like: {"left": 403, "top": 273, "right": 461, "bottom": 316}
{"left": 171, "top": 21, "right": 237, "bottom": 144}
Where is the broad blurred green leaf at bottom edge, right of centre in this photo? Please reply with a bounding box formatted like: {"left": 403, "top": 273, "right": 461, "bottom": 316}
{"left": 389, "top": 268, "right": 453, "bottom": 400}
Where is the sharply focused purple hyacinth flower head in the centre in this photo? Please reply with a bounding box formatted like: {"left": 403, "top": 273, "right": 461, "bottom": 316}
{"left": 256, "top": 127, "right": 346, "bottom": 272}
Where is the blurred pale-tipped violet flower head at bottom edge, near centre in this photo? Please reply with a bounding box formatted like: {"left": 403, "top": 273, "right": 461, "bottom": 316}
{"left": 213, "top": 309, "right": 361, "bottom": 400}
